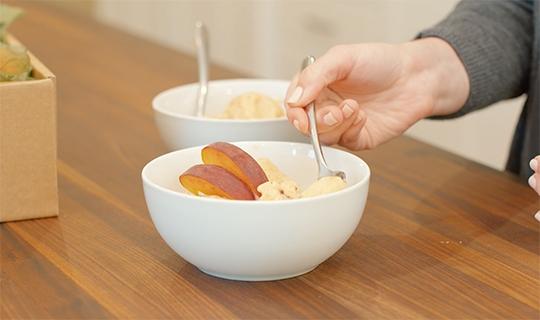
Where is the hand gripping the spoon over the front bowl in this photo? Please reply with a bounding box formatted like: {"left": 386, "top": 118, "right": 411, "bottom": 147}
{"left": 286, "top": 38, "right": 469, "bottom": 150}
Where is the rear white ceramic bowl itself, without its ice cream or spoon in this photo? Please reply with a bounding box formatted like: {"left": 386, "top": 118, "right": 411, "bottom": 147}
{"left": 152, "top": 79, "right": 308, "bottom": 150}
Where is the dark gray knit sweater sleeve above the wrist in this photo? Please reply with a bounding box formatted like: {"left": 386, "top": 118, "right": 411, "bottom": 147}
{"left": 418, "top": 0, "right": 533, "bottom": 118}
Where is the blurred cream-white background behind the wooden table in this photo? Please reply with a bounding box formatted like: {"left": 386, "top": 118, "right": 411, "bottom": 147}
{"left": 95, "top": 0, "right": 523, "bottom": 169}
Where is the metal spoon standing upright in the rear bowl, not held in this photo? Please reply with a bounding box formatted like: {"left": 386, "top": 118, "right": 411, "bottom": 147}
{"left": 195, "top": 21, "right": 209, "bottom": 117}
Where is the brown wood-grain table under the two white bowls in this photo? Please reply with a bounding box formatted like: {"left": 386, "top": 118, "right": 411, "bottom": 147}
{"left": 0, "top": 2, "right": 540, "bottom": 319}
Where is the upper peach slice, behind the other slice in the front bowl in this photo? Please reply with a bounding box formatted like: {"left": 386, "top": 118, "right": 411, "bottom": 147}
{"left": 201, "top": 142, "right": 268, "bottom": 196}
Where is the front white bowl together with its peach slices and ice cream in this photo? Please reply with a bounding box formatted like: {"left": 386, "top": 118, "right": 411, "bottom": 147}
{"left": 142, "top": 141, "right": 370, "bottom": 281}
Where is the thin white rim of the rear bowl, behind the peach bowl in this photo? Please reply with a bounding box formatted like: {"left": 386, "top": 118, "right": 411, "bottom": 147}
{"left": 152, "top": 78, "right": 290, "bottom": 124}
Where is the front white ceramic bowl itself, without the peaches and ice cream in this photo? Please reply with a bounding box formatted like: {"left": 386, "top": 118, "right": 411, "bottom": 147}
{"left": 142, "top": 142, "right": 370, "bottom": 281}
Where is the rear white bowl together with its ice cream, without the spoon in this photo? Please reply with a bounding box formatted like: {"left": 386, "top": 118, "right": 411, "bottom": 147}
{"left": 152, "top": 79, "right": 307, "bottom": 150}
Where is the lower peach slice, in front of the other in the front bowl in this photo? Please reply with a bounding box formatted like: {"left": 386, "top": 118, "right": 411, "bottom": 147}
{"left": 179, "top": 164, "right": 255, "bottom": 200}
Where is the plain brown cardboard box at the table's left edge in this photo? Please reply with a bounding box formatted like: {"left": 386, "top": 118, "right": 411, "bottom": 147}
{"left": 0, "top": 37, "right": 58, "bottom": 222}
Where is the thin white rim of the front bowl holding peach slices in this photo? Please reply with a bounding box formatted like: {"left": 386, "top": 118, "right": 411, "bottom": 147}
{"left": 141, "top": 140, "right": 371, "bottom": 206}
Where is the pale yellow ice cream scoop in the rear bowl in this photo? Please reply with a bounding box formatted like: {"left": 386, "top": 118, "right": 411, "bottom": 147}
{"left": 218, "top": 92, "right": 284, "bottom": 119}
